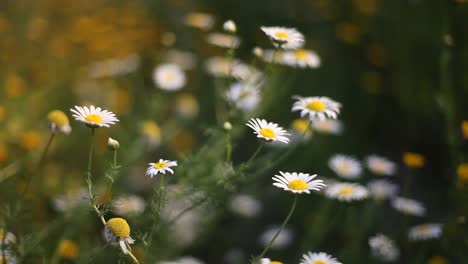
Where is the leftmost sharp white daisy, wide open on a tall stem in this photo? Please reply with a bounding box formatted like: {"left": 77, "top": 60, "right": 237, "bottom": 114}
{"left": 70, "top": 105, "right": 119, "bottom": 128}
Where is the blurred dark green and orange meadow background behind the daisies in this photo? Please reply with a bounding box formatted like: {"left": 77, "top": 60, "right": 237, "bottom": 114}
{"left": 0, "top": 0, "right": 468, "bottom": 264}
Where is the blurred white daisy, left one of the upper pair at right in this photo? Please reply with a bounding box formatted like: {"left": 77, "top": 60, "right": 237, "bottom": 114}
{"left": 328, "top": 154, "right": 362, "bottom": 179}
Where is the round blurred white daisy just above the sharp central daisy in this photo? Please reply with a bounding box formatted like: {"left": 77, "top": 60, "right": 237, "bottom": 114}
{"left": 226, "top": 82, "right": 260, "bottom": 112}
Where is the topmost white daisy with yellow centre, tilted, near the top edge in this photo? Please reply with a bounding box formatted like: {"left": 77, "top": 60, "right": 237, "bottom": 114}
{"left": 261, "top": 27, "right": 304, "bottom": 49}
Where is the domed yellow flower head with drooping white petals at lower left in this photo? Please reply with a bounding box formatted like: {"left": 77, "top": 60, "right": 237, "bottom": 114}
{"left": 105, "top": 217, "right": 135, "bottom": 254}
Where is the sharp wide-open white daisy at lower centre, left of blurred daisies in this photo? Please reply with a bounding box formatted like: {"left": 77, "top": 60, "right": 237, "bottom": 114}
{"left": 272, "top": 171, "right": 325, "bottom": 193}
